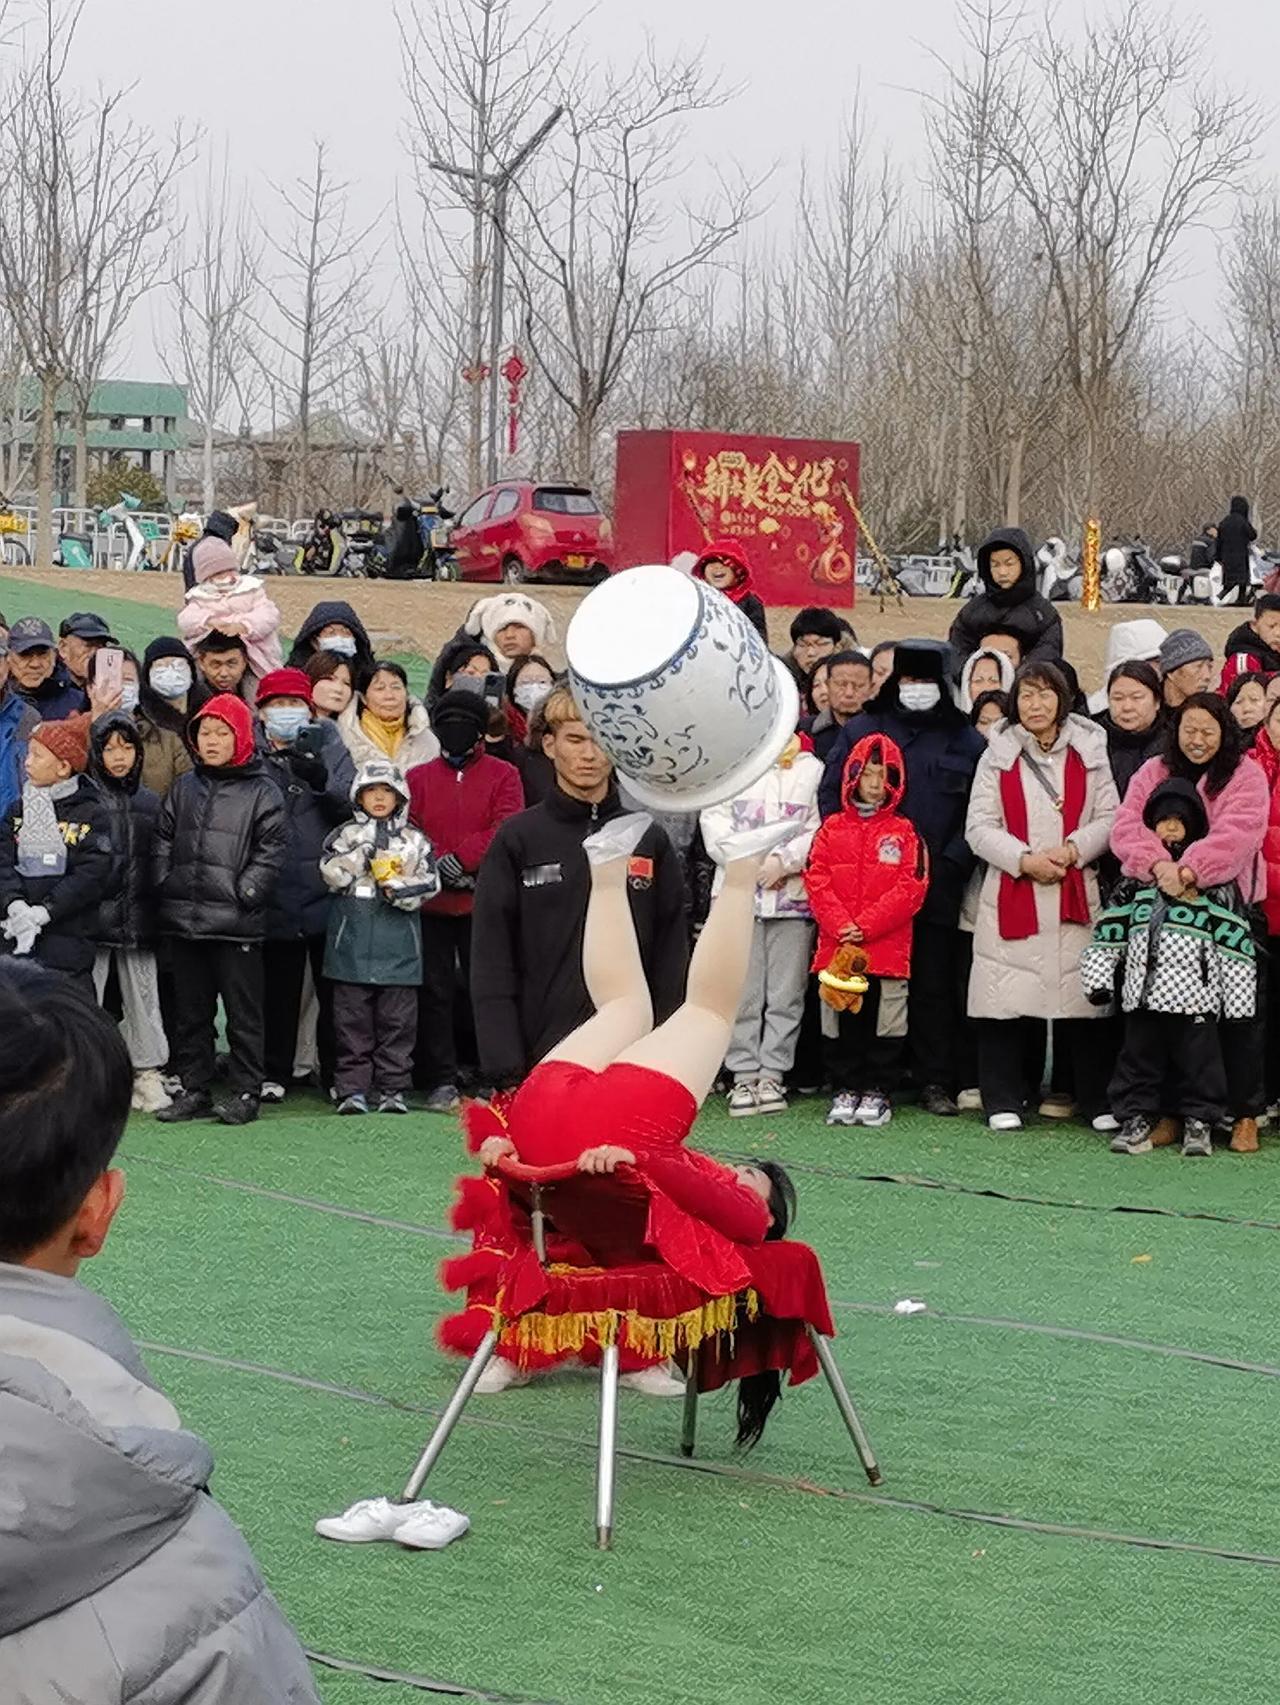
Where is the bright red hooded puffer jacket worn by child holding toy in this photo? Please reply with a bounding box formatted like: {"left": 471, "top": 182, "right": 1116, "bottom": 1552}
{"left": 804, "top": 735, "right": 929, "bottom": 977}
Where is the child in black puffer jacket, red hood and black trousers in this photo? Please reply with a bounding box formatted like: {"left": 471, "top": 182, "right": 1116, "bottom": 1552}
{"left": 155, "top": 692, "right": 288, "bottom": 1125}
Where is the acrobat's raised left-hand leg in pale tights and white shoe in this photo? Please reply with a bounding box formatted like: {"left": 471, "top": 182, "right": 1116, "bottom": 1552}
{"left": 545, "top": 813, "right": 653, "bottom": 1071}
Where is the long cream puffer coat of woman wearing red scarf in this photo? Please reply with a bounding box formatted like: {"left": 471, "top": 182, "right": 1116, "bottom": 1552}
{"left": 965, "top": 716, "right": 1118, "bottom": 1018}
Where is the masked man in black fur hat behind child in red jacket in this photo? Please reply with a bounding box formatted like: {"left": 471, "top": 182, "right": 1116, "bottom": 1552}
{"left": 818, "top": 639, "right": 987, "bottom": 1115}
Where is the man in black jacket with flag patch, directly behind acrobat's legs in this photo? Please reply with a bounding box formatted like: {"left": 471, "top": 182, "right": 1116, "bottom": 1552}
{"left": 470, "top": 687, "right": 689, "bottom": 1088}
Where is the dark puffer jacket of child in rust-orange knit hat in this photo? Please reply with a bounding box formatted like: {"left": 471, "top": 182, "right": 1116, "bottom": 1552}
{"left": 0, "top": 776, "right": 116, "bottom": 975}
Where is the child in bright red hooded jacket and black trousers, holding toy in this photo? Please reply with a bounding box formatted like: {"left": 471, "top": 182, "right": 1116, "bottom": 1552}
{"left": 804, "top": 735, "right": 929, "bottom": 1129}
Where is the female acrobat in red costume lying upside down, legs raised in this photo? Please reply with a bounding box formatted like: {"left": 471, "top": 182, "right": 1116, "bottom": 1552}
{"left": 441, "top": 815, "right": 821, "bottom": 1430}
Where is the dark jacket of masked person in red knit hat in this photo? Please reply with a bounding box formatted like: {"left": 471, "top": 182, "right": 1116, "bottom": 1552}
{"left": 262, "top": 721, "right": 356, "bottom": 941}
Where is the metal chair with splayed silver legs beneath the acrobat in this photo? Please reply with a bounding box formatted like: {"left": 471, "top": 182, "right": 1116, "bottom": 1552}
{"left": 401, "top": 1158, "right": 883, "bottom": 1552}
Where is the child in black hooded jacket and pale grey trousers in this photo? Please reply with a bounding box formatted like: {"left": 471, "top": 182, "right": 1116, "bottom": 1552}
{"left": 89, "top": 711, "right": 170, "bottom": 1113}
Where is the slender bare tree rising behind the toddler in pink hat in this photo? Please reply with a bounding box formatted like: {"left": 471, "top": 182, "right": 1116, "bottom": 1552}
{"left": 165, "top": 153, "right": 257, "bottom": 515}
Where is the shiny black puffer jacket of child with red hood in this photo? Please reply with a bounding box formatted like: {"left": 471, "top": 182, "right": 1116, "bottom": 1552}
{"left": 155, "top": 736, "right": 288, "bottom": 941}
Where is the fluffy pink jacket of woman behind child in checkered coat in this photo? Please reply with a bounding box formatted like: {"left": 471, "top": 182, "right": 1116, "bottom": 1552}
{"left": 1111, "top": 757, "right": 1271, "bottom": 900}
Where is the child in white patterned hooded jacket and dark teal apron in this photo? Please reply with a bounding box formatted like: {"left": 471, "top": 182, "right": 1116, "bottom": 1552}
{"left": 320, "top": 759, "right": 440, "bottom": 1113}
